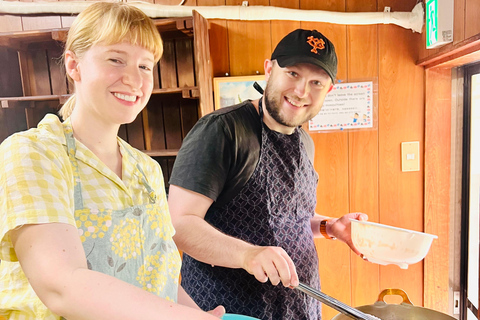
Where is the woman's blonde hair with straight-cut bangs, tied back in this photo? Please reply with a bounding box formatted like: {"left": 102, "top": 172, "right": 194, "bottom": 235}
{"left": 59, "top": 2, "right": 163, "bottom": 119}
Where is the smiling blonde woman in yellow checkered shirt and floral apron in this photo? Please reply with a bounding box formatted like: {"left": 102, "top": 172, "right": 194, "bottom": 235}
{"left": 0, "top": 3, "right": 224, "bottom": 320}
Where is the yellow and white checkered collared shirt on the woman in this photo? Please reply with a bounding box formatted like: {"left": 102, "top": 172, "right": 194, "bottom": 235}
{"left": 0, "top": 115, "right": 168, "bottom": 320}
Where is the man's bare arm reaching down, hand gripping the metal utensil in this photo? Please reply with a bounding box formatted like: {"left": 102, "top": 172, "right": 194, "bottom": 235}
{"left": 168, "top": 185, "right": 298, "bottom": 286}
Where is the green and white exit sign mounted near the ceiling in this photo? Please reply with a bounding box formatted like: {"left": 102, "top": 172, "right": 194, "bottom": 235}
{"left": 425, "top": 0, "right": 454, "bottom": 49}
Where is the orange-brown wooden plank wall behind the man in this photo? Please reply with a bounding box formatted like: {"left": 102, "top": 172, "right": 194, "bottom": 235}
{"left": 0, "top": 0, "right": 458, "bottom": 319}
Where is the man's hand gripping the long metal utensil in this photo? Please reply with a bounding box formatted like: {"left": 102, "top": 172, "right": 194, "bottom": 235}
{"left": 243, "top": 246, "right": 298, "bottom": 287}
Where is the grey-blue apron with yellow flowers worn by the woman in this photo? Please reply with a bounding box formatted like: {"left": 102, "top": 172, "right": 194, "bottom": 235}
{"left": 64, "top": 122, "right": 181, "bottom": 301}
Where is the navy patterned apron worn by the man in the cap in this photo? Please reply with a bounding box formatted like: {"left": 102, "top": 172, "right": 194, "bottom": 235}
{"left": 182, "top": 99, "right": 321, "bottom": 320}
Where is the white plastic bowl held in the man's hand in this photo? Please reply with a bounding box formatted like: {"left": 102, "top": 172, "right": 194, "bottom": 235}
{"left": 350, "top": 219, "right": 438, "bottom": 269}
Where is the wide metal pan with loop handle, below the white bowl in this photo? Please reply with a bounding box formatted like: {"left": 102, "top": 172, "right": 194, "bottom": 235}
{"left": 332, "top": 289, "right": 455, "bottom": 320}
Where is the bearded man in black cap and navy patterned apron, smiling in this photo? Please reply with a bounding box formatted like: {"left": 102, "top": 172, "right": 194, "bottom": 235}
{"left": 169, "top": 29, "right": 367, "bottom": 320}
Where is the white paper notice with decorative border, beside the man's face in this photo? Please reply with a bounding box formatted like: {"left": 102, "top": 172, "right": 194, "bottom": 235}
{"left": 308, "top": 81, "right": 373, "bottom": 131}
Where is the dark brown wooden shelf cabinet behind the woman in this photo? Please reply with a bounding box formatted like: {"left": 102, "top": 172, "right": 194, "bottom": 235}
{"left": 0, "top": 12, "right": 213, "bottom": 189}
